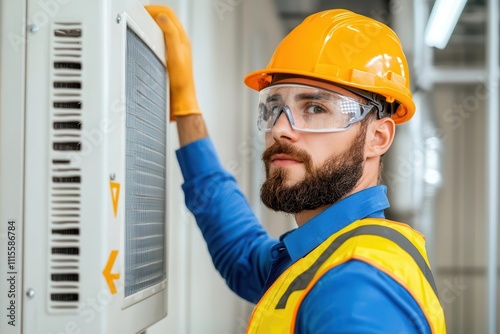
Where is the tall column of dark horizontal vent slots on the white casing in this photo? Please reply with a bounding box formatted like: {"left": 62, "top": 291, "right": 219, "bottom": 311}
{"left": 48, "top": 22, "right": 85, "bottom": 313}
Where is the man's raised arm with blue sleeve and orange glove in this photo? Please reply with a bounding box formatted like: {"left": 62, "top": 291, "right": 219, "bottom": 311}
{"left": 146, "top": 6, "right": 277, "bottom": 302}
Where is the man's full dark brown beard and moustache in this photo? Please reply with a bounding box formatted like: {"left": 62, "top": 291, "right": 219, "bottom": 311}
{"left": 260, "top": 131, "right": 366, "bottom": 214}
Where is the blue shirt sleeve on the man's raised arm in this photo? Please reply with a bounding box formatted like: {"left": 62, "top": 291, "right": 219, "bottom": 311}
{"left": 176, "top": 138, "right": 278, "bottom": 303}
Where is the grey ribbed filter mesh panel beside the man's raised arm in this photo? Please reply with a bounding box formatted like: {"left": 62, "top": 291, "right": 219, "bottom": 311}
{"left": 125, "top": 29, "right": 167, "bottom": 296}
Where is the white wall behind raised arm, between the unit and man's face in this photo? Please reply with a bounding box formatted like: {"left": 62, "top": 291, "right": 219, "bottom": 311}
{"left": 148, "top": 0, "right": 283, "bottom": 334}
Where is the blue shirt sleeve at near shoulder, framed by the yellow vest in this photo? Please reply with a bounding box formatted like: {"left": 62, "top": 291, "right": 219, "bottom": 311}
{"left": 296, "top": 260, "right": 431, "bottom": 334}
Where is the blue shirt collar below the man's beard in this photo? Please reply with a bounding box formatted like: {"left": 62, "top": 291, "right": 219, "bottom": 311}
{"left": 280, "top": 185, "right": 389, "bottom": 262}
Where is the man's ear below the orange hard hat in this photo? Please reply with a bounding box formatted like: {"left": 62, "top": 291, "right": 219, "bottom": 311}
{"left": 365, "top": 117, "right": 396, "bottom": 158}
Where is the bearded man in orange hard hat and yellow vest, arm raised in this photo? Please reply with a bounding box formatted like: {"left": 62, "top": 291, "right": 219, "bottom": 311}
{"left": 147, "top": 6, "right": 446, "bottom": 334}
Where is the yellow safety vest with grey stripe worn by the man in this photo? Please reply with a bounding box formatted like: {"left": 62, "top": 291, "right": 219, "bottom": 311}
{"left": 247, "top": 218, "right": 446, "bottom": 334}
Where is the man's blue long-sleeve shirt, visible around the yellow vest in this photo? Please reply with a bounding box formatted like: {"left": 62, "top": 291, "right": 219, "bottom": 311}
{"left": 176, "top": 138, "right": 431, "bottom": 334}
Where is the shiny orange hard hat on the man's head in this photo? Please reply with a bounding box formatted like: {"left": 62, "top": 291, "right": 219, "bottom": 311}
{"left": 244, "top": 9, "right": 415, "bottom": 124}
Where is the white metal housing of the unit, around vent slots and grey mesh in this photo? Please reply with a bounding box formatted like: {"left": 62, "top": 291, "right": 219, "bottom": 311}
{"left": 0, "top": 0, "right": 168, "bottom": 333}
